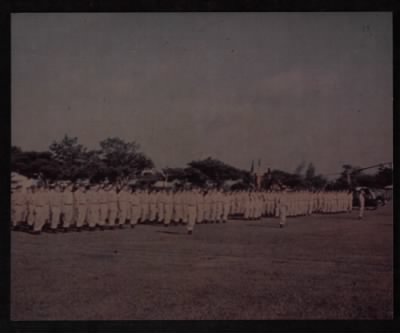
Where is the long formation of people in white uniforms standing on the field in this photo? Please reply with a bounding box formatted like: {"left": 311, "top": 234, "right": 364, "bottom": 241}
{"left": 11, "top": 182, "right": 353, "bottom": 234}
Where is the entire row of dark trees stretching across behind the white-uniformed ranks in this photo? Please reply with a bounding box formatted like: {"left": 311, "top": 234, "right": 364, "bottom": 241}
{"left": 11, "top": 135, "right": 393, "bottom": 189}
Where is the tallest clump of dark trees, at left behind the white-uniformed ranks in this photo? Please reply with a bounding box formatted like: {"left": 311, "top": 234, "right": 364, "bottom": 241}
{"left": 11, "top": 135, "right": 154, "bottom": 182}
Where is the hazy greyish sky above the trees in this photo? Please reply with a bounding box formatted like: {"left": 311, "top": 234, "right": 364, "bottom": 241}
{"left": 12, "top": 13, "right": 393, "bottom": 173}
